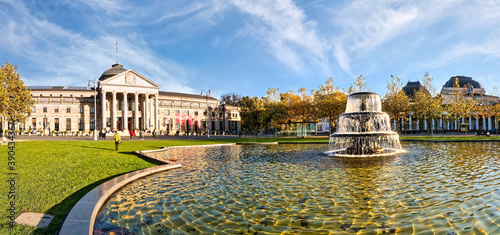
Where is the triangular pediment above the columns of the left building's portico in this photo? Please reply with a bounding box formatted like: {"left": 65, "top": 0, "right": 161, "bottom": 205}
{"left": 101, "top": 69, "right": 160, "bottom": 89}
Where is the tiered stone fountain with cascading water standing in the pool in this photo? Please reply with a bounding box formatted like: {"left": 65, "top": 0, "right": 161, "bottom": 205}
{"left": 326, "top": 92, "right": 404, "bottom": 157}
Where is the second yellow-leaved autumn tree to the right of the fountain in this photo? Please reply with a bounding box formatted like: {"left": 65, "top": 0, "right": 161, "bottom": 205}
{"left": 412, "top": 72, "right": 443, "bottom": 135}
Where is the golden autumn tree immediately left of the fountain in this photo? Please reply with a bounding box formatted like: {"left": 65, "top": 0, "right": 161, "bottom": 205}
{"left": 314, "top": 78, "right": 347, "bottom": 134}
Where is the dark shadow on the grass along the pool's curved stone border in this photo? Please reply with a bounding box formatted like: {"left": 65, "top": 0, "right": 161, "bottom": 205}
{"left": 33, "top": 151, "right": 159, "bottom": 235}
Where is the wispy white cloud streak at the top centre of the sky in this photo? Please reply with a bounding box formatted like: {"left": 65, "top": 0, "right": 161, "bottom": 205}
{"left": 227, "top": 0, "right": 328, "bottom": 71}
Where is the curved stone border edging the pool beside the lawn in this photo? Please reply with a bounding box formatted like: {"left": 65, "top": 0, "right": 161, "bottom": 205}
{"left": 59, "top": 163, "right": 181, "bottom": 235}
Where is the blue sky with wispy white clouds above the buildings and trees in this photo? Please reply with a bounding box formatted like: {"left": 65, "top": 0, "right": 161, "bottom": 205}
{"left": 0, "top": 0, "right": 500, "bottom": 98}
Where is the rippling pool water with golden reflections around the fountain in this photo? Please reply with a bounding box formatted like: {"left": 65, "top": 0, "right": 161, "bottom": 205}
{"left": 94, "top": 142, "right": 500, "bottom": 235}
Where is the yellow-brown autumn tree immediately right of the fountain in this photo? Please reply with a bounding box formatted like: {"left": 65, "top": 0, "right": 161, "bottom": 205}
{"left": 382, "top": 75, "right": 410, "bottom": 130}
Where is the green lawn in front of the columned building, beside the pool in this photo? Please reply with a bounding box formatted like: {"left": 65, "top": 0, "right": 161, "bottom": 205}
{"left": 0, "top": 138, "right": 328, "bottom": 234}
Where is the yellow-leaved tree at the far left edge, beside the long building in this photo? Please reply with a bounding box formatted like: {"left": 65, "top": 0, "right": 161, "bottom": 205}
{"left": 0, "top": 63, "right": 35, "bottom": 124}
